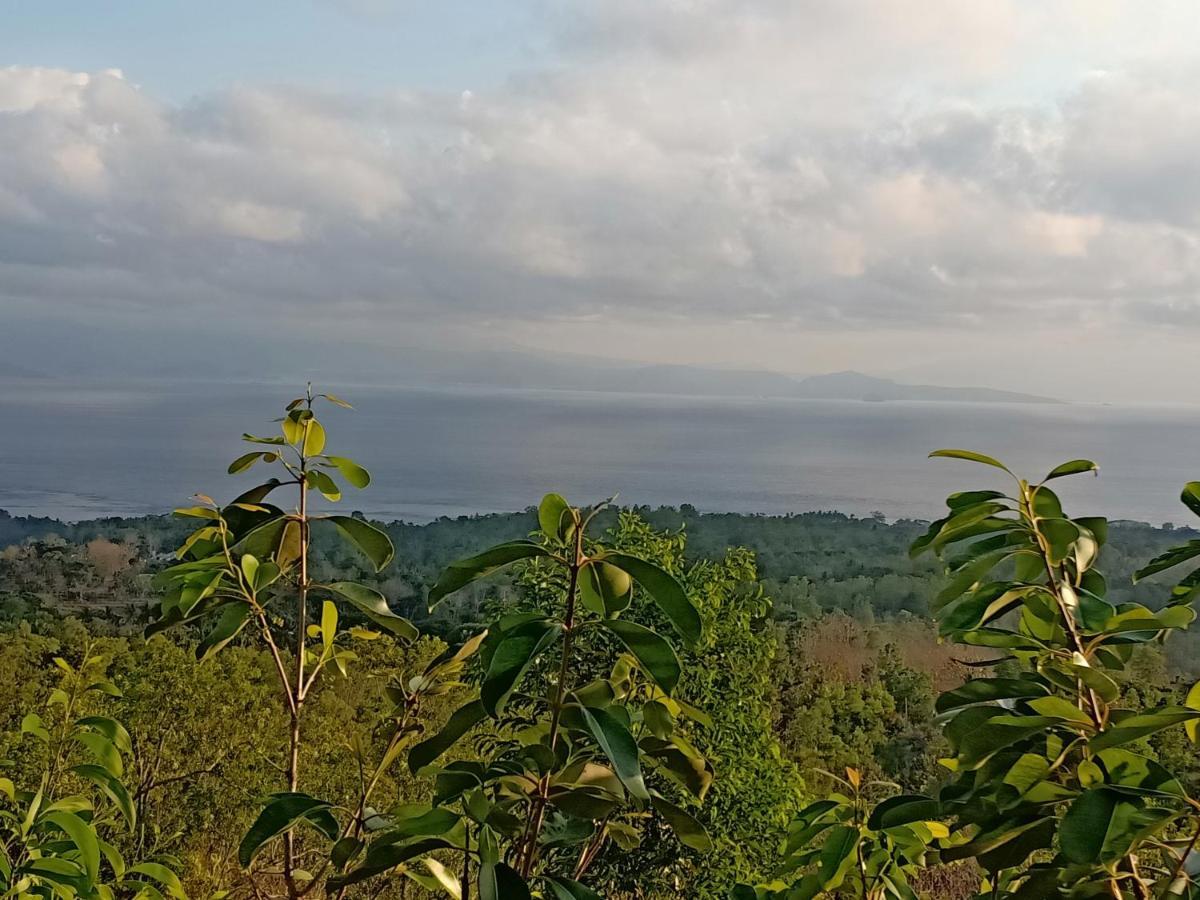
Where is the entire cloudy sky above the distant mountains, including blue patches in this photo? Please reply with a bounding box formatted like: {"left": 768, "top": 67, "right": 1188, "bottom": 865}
{"left": 0, "top": 0, "right": 1200, "bottom": 402}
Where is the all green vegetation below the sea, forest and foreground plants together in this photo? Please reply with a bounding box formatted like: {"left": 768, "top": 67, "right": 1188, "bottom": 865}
{"left": 0, "top": 394, "right": 1200, "bottom": 900}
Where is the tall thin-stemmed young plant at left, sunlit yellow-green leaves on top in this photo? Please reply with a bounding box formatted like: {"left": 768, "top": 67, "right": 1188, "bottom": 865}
{"left": 148, "top": 385, "right": 418, "bottom": 898}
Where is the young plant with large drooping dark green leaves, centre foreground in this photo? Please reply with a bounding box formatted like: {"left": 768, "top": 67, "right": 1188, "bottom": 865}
{"left": 330, "top": 494, "right": 713, "bottom": 900}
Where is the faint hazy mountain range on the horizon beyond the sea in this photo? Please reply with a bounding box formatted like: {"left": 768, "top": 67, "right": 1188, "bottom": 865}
{"left": 0, "top": 319, "right": 1058, "bottom": 403}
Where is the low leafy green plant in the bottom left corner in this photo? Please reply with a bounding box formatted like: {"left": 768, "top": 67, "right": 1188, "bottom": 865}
{"left": 0, "top": 647, "right": 186, "bottom": 900}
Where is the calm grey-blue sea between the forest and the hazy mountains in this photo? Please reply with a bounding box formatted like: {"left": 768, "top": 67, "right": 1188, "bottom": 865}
{"left": 0, "top": 383, "right": 1200, "bottom": 524}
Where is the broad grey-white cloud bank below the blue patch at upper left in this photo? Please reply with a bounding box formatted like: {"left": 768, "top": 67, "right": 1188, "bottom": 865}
{"left": 0, "top": 0, "right": 1200, "bottom": 398}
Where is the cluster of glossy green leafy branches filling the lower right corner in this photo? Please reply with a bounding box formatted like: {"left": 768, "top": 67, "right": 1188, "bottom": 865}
{"left": 756, "top": 450, "right": 1200, "bottom": 900}
